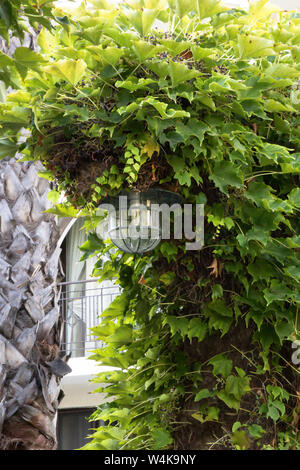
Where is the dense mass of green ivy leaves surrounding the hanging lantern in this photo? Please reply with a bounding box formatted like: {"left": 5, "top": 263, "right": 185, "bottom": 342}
{"left": 0, "top": 0, "right": 300, "bottom": 450}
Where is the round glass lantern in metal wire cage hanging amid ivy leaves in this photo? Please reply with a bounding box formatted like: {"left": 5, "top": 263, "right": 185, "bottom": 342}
{"left": 101, "top": 188, "right": 183, "bottom": 253}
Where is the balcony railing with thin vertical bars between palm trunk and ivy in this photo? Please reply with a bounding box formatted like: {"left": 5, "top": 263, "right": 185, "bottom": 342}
{"left": 58, "top": 280, "right": 120, "bottom": 357}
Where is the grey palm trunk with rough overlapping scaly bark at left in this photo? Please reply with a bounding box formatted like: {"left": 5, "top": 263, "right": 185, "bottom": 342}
{"left": 0, "top": 159, "right": 70, "bottom": 449}
